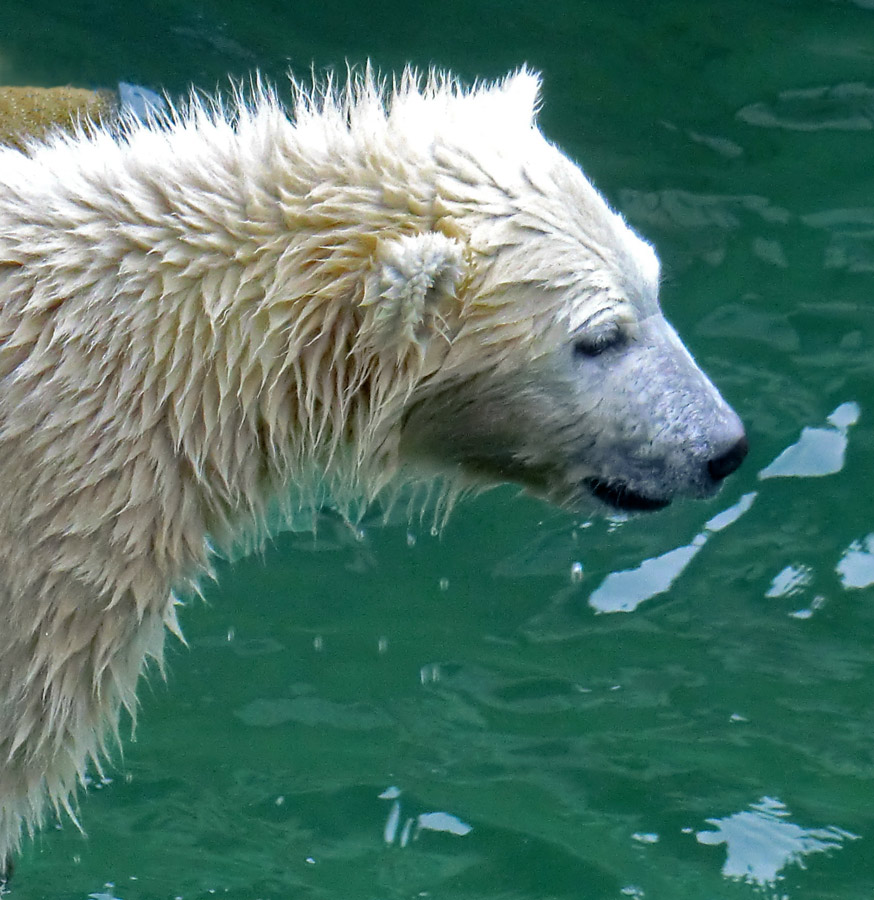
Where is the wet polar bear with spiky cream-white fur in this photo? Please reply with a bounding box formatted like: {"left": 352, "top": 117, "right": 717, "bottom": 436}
{"left": 0, "top": 69, "right": 746, "bottom": 880}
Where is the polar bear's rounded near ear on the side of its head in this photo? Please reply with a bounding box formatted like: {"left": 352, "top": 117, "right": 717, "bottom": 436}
{"left": 361, "top": 231, "right": 465, "bottom": 354}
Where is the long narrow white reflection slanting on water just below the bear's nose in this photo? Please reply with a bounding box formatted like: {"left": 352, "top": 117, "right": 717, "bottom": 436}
{"left": 589, "top": 491, "right": 756, "bottom": 613}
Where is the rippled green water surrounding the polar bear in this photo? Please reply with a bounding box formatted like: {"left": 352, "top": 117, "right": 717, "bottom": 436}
{"left": 0, "top": 0, "right": 874, "bottom": 900}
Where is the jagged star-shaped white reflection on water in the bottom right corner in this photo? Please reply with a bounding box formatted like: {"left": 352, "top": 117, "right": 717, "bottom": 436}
{"left": 695, "top": 797, "right": 859, "bottom": 887}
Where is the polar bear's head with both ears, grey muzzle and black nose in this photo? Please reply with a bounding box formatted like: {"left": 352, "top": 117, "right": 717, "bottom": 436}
{"left": 340, "top": 71, "right": 747, "bottom": 510}
